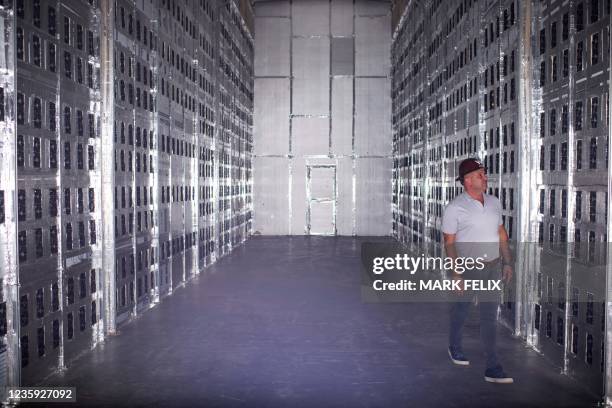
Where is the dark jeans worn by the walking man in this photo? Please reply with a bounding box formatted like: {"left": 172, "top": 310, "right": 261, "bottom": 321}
{"left": 449, "top": 263, "right": 500, "bottom": 368}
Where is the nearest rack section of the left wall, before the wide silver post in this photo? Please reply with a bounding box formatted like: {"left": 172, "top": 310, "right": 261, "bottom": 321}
{"left": 14, "top": 0, "right": 101, "bottom": 384}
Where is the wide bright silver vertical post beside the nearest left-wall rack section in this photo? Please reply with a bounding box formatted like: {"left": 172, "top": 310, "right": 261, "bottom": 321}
{"left": 100, "top": 0, "right": 117, "bottom": 334}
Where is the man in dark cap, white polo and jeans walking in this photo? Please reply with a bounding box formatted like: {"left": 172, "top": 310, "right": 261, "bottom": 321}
{"left": 442, "top": 158, "right": 513, "bottom": 384}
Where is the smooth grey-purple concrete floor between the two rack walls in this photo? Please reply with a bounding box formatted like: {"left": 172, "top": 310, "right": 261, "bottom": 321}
{"left": 45, "top": 237, "right": 597, "bottom": 407}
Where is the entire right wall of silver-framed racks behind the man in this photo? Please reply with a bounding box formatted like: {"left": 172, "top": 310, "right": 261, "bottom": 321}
{"left": 391, "top": 0, "right": 612, "bottom": 395}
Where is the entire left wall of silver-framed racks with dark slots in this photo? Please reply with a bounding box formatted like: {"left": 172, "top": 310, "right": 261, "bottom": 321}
{"left": 0, "top": 0, "right": 254, "bottom": 390}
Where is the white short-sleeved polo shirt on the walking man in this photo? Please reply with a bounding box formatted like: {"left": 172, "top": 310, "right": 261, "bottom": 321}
{"left": 442, "top": 192, "right": 503, "bottom": 262}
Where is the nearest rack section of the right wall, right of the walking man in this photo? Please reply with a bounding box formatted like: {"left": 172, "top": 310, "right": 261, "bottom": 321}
{"left": 533, "top": 1, "right": 610, "bottom": 393}
